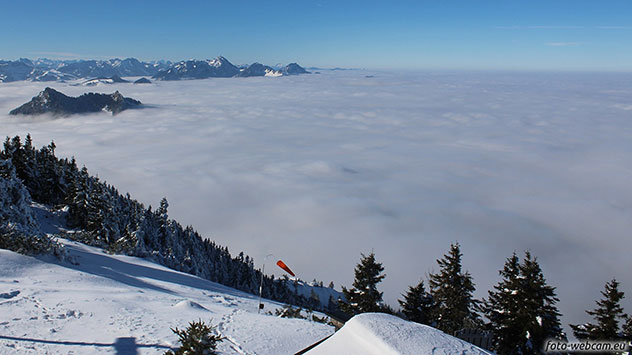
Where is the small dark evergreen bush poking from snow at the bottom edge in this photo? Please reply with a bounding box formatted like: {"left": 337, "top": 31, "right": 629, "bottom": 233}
{"left": 165, "top": 320, "right": 223, "bottom": 355}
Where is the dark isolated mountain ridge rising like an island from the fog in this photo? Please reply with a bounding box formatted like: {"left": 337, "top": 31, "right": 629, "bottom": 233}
{"left": 9, "top": 88, "right": 141, "bottom": 116}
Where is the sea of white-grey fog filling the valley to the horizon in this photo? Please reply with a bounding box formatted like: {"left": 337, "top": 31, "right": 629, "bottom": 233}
{"left": 0, "top": 70, "right": 632, "bottom": 334}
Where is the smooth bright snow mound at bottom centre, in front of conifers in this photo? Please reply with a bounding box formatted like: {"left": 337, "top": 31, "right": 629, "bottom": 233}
{"left": 307, "top": 313, "right": 491, "bottom": 355}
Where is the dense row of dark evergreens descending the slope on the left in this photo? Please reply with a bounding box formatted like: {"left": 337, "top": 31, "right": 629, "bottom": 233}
{"left": 0, "top": 136, "right": 325, "bottom": 310}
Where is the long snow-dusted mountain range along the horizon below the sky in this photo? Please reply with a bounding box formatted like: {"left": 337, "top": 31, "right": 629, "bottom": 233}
{"left": 0, "top": 56, "right": 308, "bottom": 85}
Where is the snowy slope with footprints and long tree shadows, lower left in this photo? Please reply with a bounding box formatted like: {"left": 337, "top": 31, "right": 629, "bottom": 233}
{"left": 0, "top": 240, "right": 333, "bottom": 354}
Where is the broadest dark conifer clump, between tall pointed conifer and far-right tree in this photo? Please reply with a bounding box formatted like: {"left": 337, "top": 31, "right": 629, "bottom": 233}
{"left": 482, "top": 252, "right": 565, "bottom": 355}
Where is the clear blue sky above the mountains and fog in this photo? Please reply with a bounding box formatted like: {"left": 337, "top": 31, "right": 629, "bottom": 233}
{"left": 0, "top": 0, "right": 632, "bottom": 71}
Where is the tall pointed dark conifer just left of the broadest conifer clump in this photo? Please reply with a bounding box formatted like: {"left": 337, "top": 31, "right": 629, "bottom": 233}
{"left": 429, "top": 243, "right": 479, "bottom": 335}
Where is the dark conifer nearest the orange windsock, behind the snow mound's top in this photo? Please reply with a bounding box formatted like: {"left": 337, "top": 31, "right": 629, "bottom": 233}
{"left": 340, "top": 253, "right": 386, "bottom": 315}
